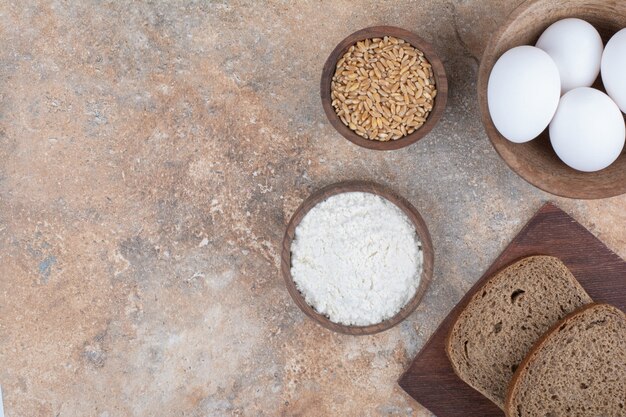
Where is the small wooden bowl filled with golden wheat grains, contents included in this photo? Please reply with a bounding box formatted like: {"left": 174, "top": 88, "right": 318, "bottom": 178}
{"left": 320, "top": 26, "right": 448, "bottom": 151}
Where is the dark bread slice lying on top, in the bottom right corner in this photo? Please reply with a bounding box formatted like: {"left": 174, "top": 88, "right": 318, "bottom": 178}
{"left": 505, "top": 304, "right": 626, "bottom": 417}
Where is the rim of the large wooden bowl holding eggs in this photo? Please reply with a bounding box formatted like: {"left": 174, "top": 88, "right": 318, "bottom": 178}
{"left": 476, "top": 0, "right": 626, "bottom": 200}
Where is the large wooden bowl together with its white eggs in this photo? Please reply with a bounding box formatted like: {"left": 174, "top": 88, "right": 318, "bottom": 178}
{"left": 478, "top": 0, "right": 626, "bottom": 199}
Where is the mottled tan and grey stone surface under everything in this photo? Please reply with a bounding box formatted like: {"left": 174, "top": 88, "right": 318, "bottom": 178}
{"left": 0, "top": 0, "right": 626, "bottom": 417}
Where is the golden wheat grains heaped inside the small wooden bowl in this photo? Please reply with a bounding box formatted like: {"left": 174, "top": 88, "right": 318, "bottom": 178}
{"left": 331, "top": 36, "right": 437, "bottom": 141}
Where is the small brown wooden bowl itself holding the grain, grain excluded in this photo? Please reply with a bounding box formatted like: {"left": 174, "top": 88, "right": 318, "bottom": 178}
{"left": 320, "top": 26, "right": 448, "bottom": 151}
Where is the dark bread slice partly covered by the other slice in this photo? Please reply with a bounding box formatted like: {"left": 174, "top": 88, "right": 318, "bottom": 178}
{"left": 446, "top": 256, "right": 593, "bottom": 409}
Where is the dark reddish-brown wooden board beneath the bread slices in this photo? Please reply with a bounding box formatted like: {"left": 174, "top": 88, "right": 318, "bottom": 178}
{"left": 398, "top": 203, "right": 626, "bottom": 417}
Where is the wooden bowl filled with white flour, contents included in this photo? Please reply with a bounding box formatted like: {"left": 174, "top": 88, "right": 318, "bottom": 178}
{"left": 281, "top": 181, "right": 434, "bottom": 335}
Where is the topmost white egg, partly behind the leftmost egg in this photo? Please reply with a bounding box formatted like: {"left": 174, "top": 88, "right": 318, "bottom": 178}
{"left": 536, "top": 18, "right": 603, "bottom": 94}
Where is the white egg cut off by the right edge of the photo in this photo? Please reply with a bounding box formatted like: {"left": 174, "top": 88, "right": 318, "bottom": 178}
{"left": 602, "top": 29, "right": 626, "bottom": 113}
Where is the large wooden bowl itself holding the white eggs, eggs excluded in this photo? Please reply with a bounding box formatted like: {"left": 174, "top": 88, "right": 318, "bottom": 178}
{"left": 478, "top": 0, "right": 626, "bottom": 199}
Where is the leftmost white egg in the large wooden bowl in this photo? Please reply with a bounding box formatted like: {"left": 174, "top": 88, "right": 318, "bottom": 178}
{"left": 487, "top": 46, "right": 561, "bottom": 143}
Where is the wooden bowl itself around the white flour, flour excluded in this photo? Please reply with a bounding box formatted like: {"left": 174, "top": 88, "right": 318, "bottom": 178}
{"left": 281, "top": 181, "right": 434, "bottom": 335}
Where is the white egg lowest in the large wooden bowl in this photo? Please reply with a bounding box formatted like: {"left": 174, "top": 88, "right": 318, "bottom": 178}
{"left": 550, "top": 87, "right": 626, "bottom": 172}
